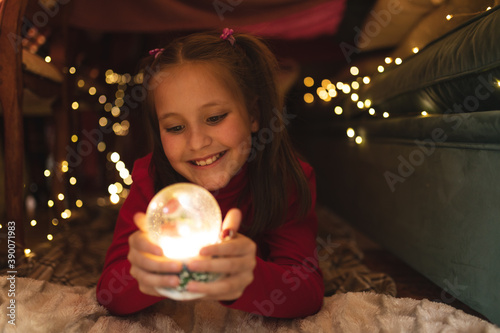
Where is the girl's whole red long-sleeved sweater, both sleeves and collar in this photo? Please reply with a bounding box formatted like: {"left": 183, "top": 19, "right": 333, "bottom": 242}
{"left": 96, "top": 154, "right": 324, "bottom": 318}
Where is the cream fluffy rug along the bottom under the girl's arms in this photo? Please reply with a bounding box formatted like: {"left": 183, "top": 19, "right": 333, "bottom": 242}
{"left": 0, "top": 276, "right": 500, "bottom": 333}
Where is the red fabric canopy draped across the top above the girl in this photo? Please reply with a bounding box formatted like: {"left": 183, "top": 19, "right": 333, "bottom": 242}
{"left": 70, "top": 0, "right": 345, "bottom": 39}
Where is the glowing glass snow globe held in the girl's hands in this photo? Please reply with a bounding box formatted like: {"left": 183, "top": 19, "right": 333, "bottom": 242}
{"left": 146, "top": 183, "right": 222, "bottom": 300}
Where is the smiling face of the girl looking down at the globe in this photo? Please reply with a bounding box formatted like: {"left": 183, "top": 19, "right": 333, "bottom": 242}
{"left": 154, "top": 63, "right": 259, "bottom": 191}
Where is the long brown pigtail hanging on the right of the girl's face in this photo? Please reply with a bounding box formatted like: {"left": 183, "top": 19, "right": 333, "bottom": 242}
{"left": 231, "top": 35, "right": 312, "bottom": 237}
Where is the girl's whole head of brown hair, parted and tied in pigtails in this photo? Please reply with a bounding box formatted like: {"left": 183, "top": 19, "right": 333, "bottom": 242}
{"left": 144, "top": 32, "right": 311, "bottom": 237}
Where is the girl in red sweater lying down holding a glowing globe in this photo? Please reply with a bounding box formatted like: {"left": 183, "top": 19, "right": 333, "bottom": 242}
{"left": 97, "top": 28, "right": 324, "bottom": 318}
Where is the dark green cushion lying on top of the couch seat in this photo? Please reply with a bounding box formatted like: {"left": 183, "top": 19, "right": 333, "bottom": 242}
{"left": 360, "top": 6, "right": 500, "bottom": 116}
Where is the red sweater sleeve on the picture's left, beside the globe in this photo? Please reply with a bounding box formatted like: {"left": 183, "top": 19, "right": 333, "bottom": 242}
{"left": 96, "top": 155, "right": 163, "bottom": 315}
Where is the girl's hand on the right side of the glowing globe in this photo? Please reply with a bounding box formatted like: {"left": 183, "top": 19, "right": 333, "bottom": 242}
{"left": 187, "top": 208, "right": 257, "bottom": 301}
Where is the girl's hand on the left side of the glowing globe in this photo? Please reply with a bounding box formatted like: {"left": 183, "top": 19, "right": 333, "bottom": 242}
{"left": 127, "top": 213, "right": 182, "bottom": 297}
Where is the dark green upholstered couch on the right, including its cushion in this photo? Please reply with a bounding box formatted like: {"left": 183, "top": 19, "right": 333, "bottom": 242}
{"left": 306, "top": 7, "right": 500, "bottom": 325}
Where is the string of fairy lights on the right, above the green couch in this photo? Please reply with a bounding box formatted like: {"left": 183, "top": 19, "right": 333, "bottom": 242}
{"left": 303, "top": 7, "right": 500, "bottom": 145}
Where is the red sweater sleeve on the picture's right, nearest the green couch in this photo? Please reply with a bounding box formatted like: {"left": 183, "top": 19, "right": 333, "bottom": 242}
{"left": 222, "top": 162, "right": 324, "bottom": 318}
